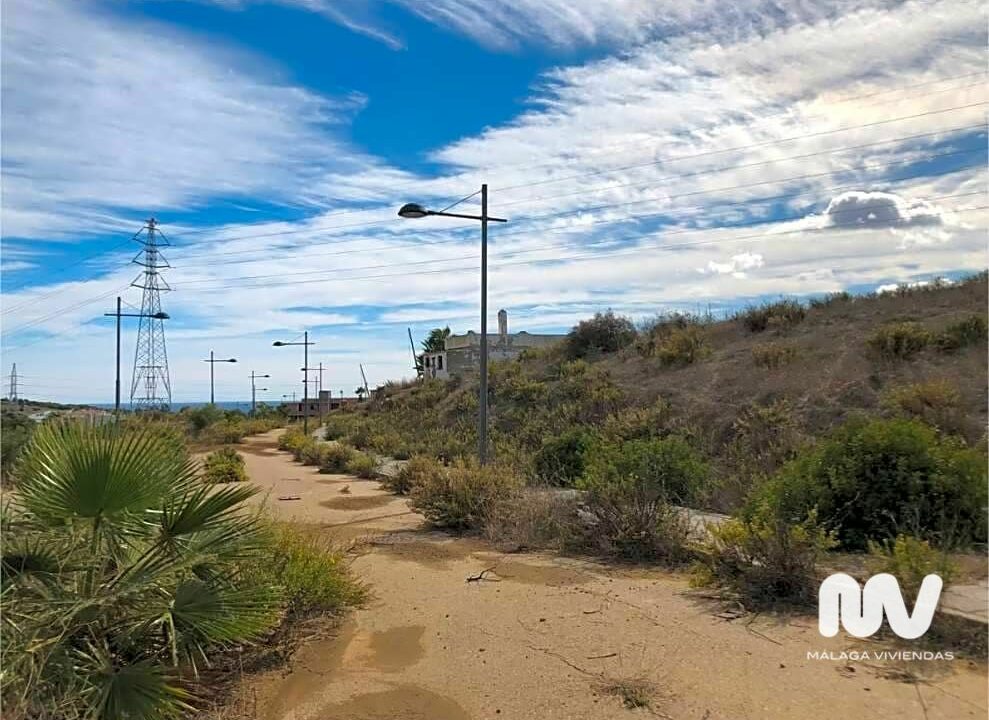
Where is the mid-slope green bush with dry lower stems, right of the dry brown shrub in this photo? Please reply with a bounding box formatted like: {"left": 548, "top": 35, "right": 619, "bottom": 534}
{"left": 579, "top": 437, "right": 707, "bottom": 564}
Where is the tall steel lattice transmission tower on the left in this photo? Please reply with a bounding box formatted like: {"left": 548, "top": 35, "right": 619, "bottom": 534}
{"left": 130, "top": 218, "right": 172, "bottom": 410}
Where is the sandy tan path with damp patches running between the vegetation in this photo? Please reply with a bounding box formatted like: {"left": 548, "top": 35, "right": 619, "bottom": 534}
{"left": 233, "top": 433, "right": 986, "bottom": 720}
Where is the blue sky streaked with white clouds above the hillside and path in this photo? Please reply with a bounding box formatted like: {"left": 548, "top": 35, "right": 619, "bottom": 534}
{"left": 0, "top": 0, "right": 989, "bottom": 402}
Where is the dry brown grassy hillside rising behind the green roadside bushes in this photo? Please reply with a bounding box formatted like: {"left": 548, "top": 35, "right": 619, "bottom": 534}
{"left": 329, "top": 274, "right": 987, "bottom": 511}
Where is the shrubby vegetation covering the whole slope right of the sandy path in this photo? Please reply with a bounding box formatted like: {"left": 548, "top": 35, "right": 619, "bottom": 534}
{"left": 282, "top": 274, "right": 987, "bottom": 608}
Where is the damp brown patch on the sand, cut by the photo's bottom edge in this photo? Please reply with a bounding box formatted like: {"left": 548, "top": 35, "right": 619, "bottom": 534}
{"left": 318, "top": 684, "right": 470, "bottom": 720}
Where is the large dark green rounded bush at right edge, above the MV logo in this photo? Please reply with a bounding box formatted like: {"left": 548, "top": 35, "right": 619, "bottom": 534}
{"left": 755, "top": 418, "right": 986, "bottom": 550}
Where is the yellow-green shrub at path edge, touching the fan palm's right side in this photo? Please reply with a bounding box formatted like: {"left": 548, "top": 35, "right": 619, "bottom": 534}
{"left": 241, "top": 523, "right": 366, "bottom": 615}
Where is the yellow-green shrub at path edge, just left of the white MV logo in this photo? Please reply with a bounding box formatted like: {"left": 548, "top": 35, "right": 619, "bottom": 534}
{"left": 695, "top": 510, "right": 835, "bottom": 608}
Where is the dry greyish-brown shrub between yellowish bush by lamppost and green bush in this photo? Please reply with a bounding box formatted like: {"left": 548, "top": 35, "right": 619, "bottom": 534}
{"left": 484, "top": 490, "right": 583, "bottom": 551}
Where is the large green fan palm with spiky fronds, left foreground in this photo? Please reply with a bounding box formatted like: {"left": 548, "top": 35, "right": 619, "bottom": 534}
{"left": 0, "top": 423, "right": 277, "bottom": 719}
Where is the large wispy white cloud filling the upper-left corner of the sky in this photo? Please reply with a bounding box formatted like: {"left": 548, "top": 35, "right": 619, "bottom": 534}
{"left": 2, "top": 0, "right": 364, "bottom": 237}
